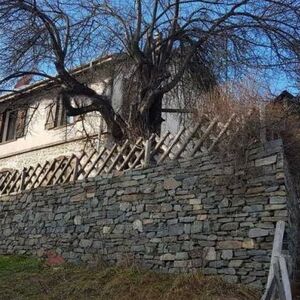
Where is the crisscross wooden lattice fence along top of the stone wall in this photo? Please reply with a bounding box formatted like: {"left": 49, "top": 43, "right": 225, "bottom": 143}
{"left": 0, "top": 114, "right": 242, "bottom": 195}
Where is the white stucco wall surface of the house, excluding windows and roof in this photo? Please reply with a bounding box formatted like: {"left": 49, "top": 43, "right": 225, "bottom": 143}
{"left": 0, "top": 67, "right": 188, "bottom": 169}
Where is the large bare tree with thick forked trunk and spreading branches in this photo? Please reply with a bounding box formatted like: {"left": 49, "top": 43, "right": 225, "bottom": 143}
{"left": 0, "top": 0, "right": 300, "bottom": 140}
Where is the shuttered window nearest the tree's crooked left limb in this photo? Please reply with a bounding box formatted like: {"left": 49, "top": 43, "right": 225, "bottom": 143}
{"left": 45, "top": 99, "right": 78, "bottom": 129}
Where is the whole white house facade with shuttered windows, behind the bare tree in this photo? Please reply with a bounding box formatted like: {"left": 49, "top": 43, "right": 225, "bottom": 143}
{"left": 0, "top": 60, "right": 186, "bottom": 169}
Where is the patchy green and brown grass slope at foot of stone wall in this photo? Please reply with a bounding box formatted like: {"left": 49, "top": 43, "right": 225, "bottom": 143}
{"left": 0, "top": 256, "right": 259, "bottom": 300}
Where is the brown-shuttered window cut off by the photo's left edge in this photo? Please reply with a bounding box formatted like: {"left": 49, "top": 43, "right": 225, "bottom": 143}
{"left": 0, "top": 109, "right": 27, "bottom": 143}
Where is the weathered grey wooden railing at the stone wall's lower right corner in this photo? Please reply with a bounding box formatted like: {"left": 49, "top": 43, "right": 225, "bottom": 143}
{"left": 261, "top": 221, "right": 292, "bottom": 300}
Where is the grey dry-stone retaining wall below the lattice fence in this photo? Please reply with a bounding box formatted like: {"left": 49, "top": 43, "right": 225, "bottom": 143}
{"left": 0, "top": 140, "right": 298, "bottom": 288}
